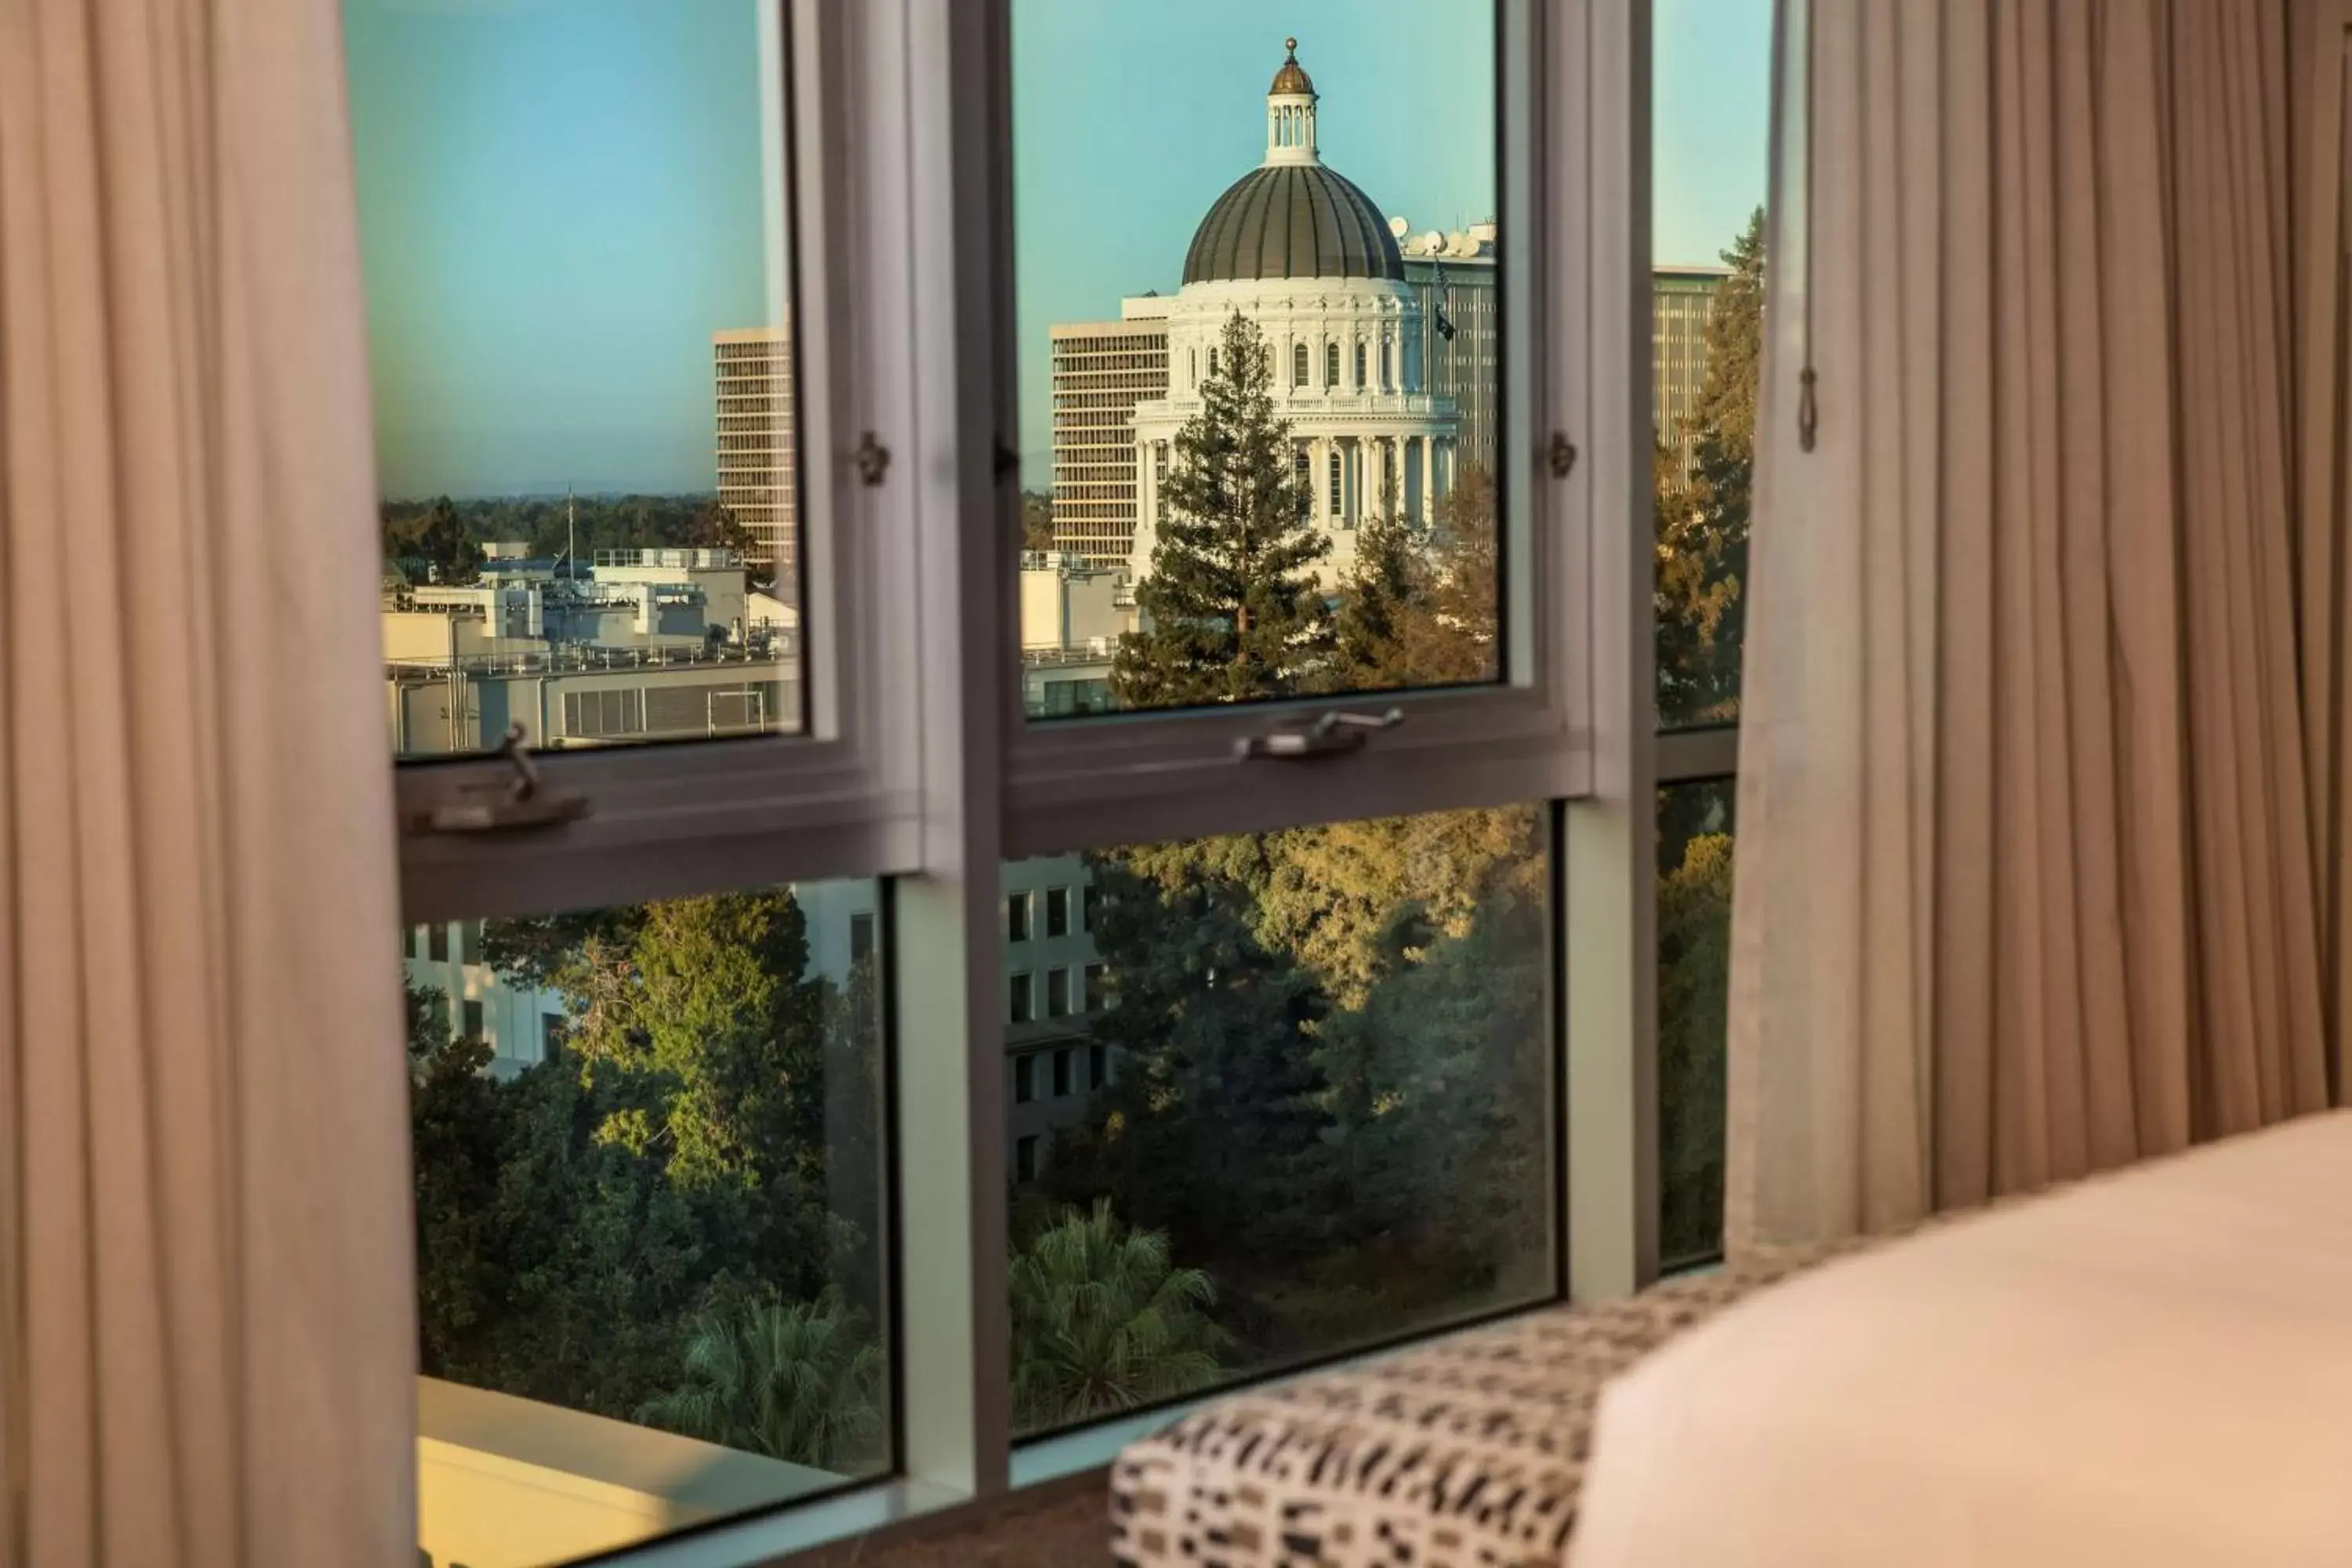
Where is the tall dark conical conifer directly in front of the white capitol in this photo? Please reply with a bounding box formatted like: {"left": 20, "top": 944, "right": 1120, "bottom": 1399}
{"left": 1110, "top": 310, "right": 1331, "bottom": 708}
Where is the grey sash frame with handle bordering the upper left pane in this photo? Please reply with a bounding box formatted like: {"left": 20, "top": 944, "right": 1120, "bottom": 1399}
{"left": 395, "top": 0, "right": 922, "bottom": 921}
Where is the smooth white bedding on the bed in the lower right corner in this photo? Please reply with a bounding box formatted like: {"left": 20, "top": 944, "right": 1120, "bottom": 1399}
{"left": 1573, "top": 1112, "right": 2352, "bottom": 1568}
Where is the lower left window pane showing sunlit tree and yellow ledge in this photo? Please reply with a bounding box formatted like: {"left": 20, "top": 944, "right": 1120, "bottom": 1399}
{"left": 405, "top": 881, "right": 891, "bottom": 1568}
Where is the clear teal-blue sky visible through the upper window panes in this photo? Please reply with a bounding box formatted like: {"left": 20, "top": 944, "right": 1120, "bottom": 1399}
{"left": 343, "top": 0, "right": 1771, "bottom": 496}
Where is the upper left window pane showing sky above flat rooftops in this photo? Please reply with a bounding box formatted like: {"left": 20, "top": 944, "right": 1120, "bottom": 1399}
{"left": 343, "top": 0, "right": 802, "bottom": 757}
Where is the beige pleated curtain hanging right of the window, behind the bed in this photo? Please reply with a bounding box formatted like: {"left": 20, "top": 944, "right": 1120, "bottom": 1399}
{"left": 1726, "top": 0, "right": 2328, "bottom": 1246}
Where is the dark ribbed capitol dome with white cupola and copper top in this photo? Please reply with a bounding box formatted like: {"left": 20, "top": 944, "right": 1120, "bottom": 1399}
{"left": 1183, "top": 38, "right": 1404, "bottom": 285}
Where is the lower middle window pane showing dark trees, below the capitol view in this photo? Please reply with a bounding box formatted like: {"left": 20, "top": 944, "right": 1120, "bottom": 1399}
{"left": 1004, "top": 808, "right": 1555, "bottom": 1434}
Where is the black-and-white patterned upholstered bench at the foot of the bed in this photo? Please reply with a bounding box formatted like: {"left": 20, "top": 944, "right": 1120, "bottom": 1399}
{"left": 1110, "top": 1241, "right": 1858, "bottom": 1568}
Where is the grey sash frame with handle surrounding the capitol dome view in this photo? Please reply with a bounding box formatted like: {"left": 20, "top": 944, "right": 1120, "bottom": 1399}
{"left": 993, "top": 0, "right": 1599, "bottom": 858}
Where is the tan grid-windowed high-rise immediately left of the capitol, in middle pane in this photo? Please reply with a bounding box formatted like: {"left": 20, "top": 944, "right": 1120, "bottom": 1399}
{"left": 1054, "top": 310, "right": 1169, "bottom": 567}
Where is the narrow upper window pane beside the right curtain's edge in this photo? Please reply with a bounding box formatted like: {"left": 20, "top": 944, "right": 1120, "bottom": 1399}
{"left": 1651, "top": 0, "right": 1773, "bottom": 729}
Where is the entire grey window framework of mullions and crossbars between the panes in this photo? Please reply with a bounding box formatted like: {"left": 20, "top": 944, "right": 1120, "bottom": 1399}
{"left": 397, "top": 0, "right": 1658, "bottom": 1563}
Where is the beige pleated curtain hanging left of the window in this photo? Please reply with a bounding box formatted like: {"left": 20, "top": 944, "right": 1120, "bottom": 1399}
{"left": 0, "top": 0, "right": 416, "bottom": 1568}
